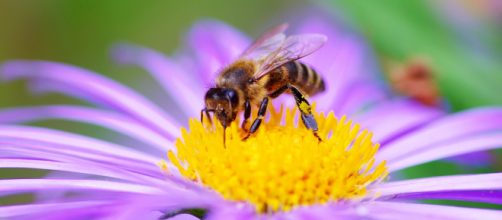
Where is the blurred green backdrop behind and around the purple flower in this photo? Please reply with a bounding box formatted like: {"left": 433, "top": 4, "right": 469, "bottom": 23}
{"left": 0, "top": 0, "right": 502, "bottom": 208}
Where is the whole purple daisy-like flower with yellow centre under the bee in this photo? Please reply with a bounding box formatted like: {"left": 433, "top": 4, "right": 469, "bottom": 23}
{"left": 0, "top": 19, "right": 502, "bottom": 219}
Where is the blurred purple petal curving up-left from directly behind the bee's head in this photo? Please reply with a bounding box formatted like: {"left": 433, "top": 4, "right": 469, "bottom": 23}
{"left": 112, "top": 44, "right": 205, "bottom": 117}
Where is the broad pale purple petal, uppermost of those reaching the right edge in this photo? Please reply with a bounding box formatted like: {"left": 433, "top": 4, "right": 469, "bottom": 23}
{"left": 377, "top": 108, "right": 502, "bottom": 162}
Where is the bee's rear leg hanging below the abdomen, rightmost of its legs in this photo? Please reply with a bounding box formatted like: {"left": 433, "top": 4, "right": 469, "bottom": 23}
{"left": 287, "top": 84, "right": 322, "bottom": 141}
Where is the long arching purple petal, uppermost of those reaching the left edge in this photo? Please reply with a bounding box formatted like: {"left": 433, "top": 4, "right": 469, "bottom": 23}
{"left": 0, "top": 61, "right": 179, "bottom": 137}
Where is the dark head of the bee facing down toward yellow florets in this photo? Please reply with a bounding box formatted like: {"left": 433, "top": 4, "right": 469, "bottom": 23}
{"left": 205, "top": 88, "right": 239, "bottom": 127}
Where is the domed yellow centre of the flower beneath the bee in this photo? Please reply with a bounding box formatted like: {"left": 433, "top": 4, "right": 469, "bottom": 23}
{"left": 162, "top": 107, "right": 387, "bottom": 213}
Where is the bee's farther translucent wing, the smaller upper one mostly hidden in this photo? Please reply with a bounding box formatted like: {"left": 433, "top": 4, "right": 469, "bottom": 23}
{"left": 240, "top": 24, "right": 288, "bottom": 60}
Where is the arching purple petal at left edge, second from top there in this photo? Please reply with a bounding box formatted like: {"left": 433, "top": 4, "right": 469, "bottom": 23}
{"left": 0, "top": 105, "right": 172, "bottom": 152}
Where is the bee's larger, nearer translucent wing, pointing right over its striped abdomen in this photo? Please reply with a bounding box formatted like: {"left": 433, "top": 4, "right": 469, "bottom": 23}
{"left": 254, "top": 34, "right": 327, "bottom": 80}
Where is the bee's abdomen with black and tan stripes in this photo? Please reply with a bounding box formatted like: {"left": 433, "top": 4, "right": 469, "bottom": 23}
{"left": 284, "top": 61, "right": 325, "bottom": 96}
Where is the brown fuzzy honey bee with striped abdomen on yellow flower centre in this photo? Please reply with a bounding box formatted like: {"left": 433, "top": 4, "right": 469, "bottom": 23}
{"left": 201, "top": 24, "right": 327, "bottom": 141}
